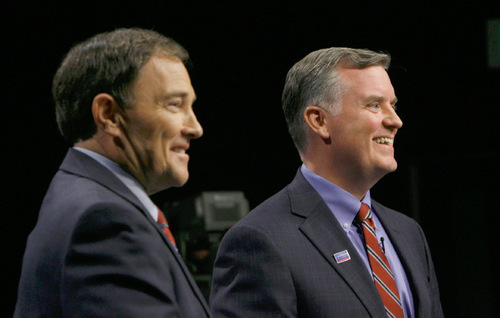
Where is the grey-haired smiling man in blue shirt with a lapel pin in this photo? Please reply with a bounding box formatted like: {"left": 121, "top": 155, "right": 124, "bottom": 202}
{"left": 210, "top": 48, "right": 443, "bottom": 318}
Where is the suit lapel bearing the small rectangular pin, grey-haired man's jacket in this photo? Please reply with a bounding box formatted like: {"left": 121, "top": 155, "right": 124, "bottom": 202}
{"left": 289, "top": 171, "right": 385, "bottom": 316}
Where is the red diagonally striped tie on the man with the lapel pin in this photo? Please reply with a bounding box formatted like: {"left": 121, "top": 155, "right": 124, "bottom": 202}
{"left": 357, "top": 203, "right": 404, "bottom": 318}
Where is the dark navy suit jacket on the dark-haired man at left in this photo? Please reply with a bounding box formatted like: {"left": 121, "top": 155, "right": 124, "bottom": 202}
{"left": 14, "top": 149, "right": 210, "bottom": 318}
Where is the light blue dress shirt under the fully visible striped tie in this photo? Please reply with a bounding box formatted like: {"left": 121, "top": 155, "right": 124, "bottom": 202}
{"left": 301, "top": 165, "right": 415, "bottom": 318}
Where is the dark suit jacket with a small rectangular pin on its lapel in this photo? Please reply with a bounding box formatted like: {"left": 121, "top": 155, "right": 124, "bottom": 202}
{"left": 210, "top": 170, "right": 443, "bottom": 318}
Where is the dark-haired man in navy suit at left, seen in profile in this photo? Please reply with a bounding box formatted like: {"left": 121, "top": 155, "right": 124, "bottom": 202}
{"left": 14, "top": 29, "right": 210, "bottom": 318}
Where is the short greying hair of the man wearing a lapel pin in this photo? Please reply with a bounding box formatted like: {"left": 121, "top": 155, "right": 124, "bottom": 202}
{"left": 282, "top": 47, "right": 391, "bottom": 152}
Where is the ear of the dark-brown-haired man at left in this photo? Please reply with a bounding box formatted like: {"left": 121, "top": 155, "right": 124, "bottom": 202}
{"left": 92, "top": 93, "right": 121, "bottom": 137}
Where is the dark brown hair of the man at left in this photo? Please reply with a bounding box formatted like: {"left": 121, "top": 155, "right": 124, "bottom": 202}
{"left": 52, "top": 28, "right": 189, "bottom": 143}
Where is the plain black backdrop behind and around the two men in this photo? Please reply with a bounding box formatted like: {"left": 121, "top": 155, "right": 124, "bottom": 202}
{"left": 0, "top": 0, "right": 500, "bottom": 317}
